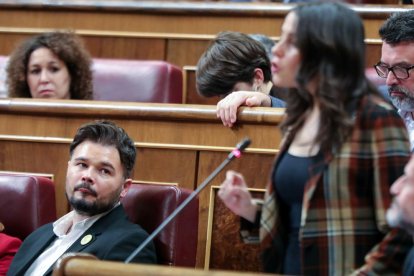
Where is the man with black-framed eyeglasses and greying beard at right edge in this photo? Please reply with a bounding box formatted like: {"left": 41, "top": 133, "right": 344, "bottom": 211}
{"left": 374, "top": 10, "right": 414, "bottom": 149}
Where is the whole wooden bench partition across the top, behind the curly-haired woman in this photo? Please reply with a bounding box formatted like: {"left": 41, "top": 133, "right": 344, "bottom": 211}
{"left": 0, "top": 0, "right": 402, "bottom": 103}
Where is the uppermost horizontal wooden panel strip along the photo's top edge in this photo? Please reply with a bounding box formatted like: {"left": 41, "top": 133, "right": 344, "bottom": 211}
{"left": 0, "top": 0, "right": 410, "bottom": 38}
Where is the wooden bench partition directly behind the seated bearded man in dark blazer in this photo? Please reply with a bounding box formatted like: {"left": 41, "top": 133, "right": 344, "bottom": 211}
{"left": 0, "top": 99, "right": 284, "bottom": 271}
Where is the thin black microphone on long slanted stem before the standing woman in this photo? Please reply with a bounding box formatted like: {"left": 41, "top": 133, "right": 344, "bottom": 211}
{"left": 125, "top": 137, "right": 251, "bottom": 264}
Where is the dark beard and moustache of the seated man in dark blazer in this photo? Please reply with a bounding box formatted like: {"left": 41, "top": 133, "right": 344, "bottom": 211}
{"left": 66, "top": 182, "right": 122, "bottom": 216}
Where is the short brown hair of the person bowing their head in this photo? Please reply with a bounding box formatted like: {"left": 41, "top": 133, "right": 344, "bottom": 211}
{"left": 196, "top": 32, "right": 272, "bottom": 97}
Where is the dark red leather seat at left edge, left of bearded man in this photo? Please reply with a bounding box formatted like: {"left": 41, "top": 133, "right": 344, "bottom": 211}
{"left": 0, "top": 174, "right": 56, "bottom": 240}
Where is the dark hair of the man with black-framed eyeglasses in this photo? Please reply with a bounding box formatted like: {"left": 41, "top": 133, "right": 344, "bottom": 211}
{"left": 379, "top": 10, "right": 414, "bottom": 45}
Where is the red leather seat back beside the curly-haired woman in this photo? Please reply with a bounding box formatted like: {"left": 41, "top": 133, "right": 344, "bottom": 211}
{"left": 93, "top": 58, "right": 183, "bottom": 103}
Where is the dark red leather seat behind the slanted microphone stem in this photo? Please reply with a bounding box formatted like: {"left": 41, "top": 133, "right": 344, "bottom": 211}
{"left": 122, "top": 184, "right": 198, "bottom": 267}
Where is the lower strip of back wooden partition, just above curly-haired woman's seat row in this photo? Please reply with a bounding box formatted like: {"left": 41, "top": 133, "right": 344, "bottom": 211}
{"left": 0, "top": 29, "right": 381, "bottom": 67}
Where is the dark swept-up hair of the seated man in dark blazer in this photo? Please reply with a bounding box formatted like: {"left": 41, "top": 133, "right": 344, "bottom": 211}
{"left": 69, "top": 121, "right": 136, "bottom": 178}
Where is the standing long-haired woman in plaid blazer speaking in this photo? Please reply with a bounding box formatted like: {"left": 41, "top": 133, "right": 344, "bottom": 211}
{"left": 219, "top": 2, "right": 412, "bottom": 275}
